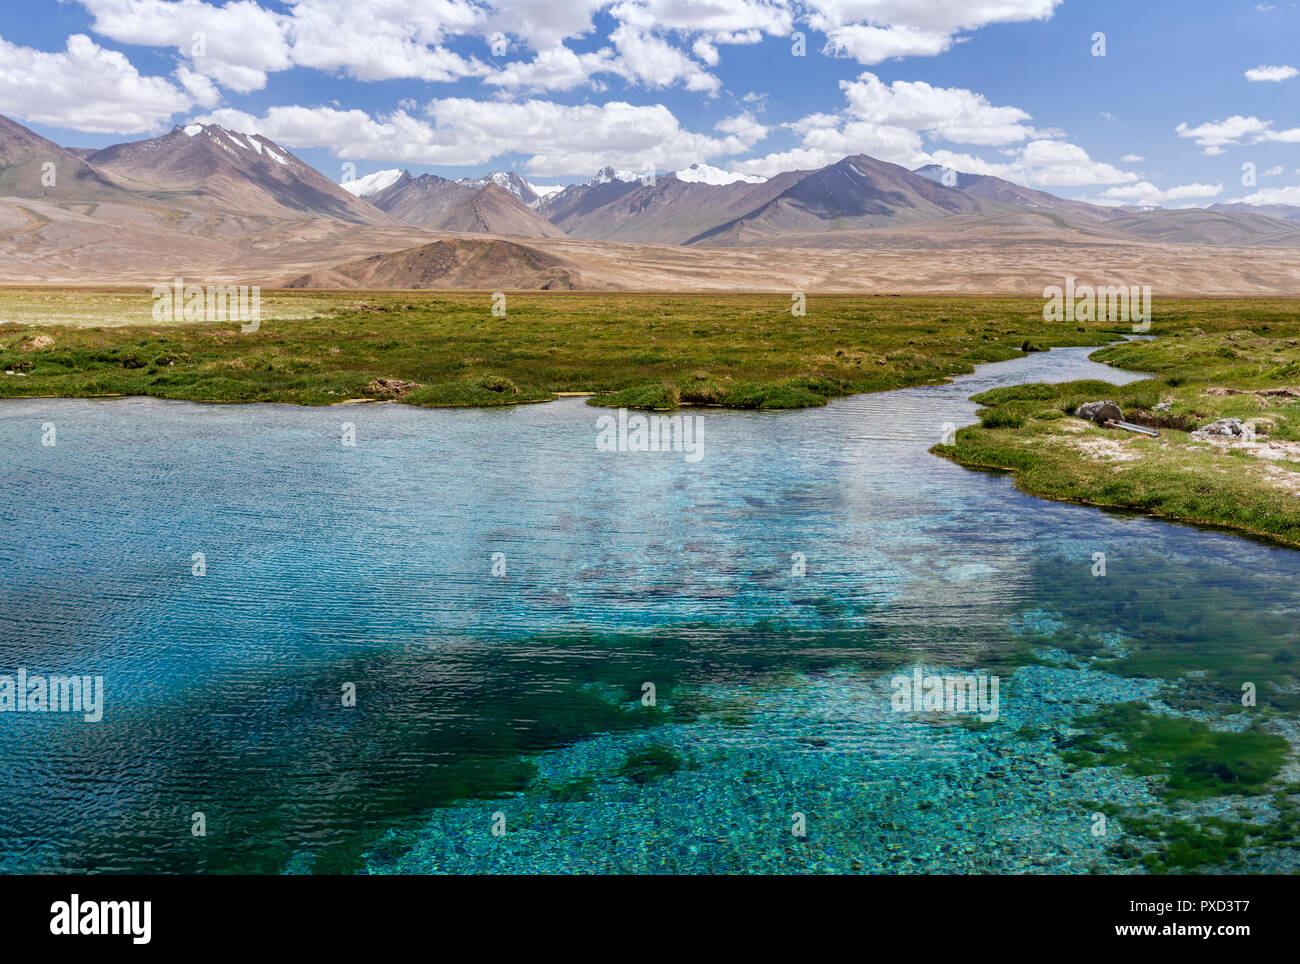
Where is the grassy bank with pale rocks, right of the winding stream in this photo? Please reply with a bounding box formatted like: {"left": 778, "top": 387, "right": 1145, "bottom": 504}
{"left": 935, "top": 313, "right": 1300, "bottom": 546}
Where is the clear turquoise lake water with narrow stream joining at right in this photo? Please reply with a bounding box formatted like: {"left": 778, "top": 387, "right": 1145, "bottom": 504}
{"left": 0, "top": 348, "right": 1300, "bottom": 873}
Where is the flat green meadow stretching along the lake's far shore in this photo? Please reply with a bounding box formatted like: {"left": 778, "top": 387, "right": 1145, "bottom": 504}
{"left": 0, "top": 288, "right": 1115, "bottom": 409}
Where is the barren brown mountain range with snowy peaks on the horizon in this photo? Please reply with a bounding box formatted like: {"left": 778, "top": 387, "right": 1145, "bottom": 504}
{"left": 0, "top": 117, "right": 1300, "bottom": 290}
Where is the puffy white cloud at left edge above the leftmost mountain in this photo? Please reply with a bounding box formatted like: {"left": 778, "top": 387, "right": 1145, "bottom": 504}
{"left": 0, "top": 34, "right": 191, "bottom": 134}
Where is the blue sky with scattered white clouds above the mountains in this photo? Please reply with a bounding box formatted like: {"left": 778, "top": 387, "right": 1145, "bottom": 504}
{"left": 0, "top": 0, "right": 1300, "bottom": 208}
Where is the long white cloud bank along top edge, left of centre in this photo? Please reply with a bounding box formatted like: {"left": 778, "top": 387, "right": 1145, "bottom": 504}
{"left": 81, "top": 0, "right": 793, "bottom": 94}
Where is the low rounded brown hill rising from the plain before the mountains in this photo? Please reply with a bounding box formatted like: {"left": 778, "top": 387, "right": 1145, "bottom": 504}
{"left": 286, "top": 238, "right": 579, "bottom": 291}
